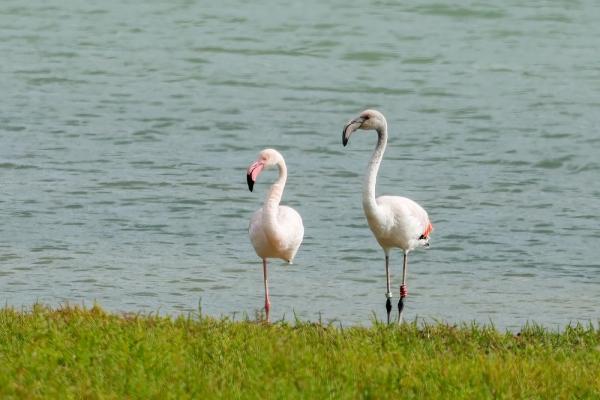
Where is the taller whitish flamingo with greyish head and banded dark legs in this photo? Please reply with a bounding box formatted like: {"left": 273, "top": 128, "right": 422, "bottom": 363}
{"left": 342, "top": 110, "right": 433, "bottom": 324}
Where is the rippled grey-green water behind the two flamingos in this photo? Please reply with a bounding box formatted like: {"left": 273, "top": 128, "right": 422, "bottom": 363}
{"left": 0, "top": 0, "right": 600, "bottom": 329}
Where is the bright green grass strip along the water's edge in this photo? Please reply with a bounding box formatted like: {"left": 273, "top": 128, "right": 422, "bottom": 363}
{"left": 0, "top": 305, "right": 600, "bottom": 399}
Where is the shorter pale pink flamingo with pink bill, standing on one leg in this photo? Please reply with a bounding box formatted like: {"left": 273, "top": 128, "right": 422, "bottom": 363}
{"left": 246, "top": 149, "right": 304, "bottom": 322}
